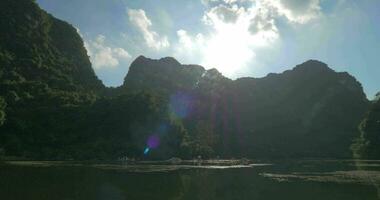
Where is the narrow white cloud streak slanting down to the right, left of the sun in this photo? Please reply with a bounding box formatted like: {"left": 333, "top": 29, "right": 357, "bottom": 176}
{"left": 127, "top": 9, "right": 170, "bottom": 50}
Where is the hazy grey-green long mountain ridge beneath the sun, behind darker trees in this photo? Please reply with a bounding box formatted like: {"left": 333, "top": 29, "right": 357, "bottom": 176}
{"left": 122, "top": 57, "right": 369, "bottom": 157}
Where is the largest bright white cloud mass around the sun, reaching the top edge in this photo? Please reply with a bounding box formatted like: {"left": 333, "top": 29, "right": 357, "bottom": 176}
{"left": 175, "top": 0, "right": 321, "bottom": 77}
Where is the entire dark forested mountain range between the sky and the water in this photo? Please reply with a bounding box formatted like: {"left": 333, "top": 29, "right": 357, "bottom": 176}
{"left": 0, "top": 0, "right": 374, "bottom": 160}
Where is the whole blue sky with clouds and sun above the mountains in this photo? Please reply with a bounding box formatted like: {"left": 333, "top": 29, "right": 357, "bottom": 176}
{"left": 37, "top": 0, "right": 380, "bottom": 99}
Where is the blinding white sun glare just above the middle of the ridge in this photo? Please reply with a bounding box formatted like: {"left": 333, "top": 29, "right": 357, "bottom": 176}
{"left": 202, "top": 6, "right": 277, "bottom": 77}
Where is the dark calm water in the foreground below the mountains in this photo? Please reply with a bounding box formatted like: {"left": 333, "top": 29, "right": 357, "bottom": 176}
{"left": 0, "top": 160, "right": 380, "bottom": 200}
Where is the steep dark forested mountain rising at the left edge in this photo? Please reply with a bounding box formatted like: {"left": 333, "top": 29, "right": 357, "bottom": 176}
{"left": 0, "top": 0, "right": 100, "bottom": 157}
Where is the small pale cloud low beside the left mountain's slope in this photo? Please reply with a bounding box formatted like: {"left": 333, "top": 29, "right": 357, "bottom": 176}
{"left": 85, "top": 35, "right": 131, "bottom": 69}
